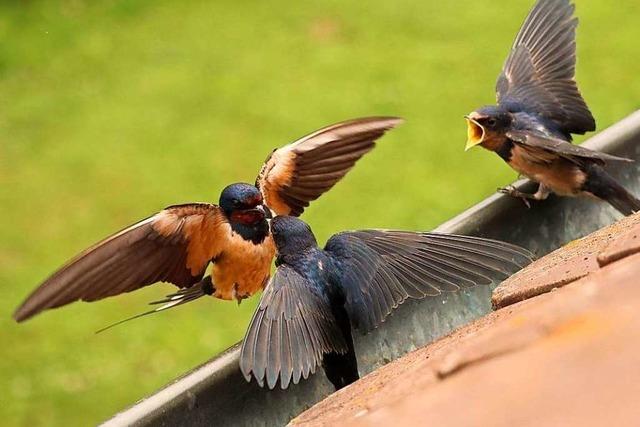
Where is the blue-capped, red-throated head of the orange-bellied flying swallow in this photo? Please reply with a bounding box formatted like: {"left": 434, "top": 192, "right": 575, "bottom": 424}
{"left": 219, "top": 183, "right": 271, "bottom": 225}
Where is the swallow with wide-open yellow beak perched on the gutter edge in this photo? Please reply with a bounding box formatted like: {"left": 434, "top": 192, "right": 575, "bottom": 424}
{"left": 465, "top": 0, "right": 640, "bottom": 215}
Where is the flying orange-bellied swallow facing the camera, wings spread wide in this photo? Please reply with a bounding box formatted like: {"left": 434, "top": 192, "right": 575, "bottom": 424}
{"left": 14, "top": 117, "right": 402, "bottom": 322}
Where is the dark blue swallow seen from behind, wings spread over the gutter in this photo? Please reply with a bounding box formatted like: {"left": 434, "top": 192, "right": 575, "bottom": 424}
{"left": 240, "top": 216, "right": 533, "bottom": 390}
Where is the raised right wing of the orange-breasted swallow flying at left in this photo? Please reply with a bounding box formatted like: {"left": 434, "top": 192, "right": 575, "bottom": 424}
{"left": 256, "top": 117, "right": 402, "bottom": 216}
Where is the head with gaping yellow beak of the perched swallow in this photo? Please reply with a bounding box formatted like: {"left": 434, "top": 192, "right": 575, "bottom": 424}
{"left": 464, "top": 106, "right": 512, "bottom": 151}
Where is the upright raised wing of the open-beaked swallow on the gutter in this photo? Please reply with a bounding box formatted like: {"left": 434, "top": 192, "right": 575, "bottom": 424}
{"left": 496, "top": 0, "right": 596, "bottom": 136}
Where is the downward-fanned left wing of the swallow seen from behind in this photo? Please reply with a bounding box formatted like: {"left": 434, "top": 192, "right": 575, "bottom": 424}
{"left": 240, "top": 265, "right": 347, "bottom": 389}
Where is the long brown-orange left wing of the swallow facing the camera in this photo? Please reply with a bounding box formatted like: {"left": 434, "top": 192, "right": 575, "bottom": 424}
{"left": 14, "top": 203, "right": 228, "bottom": 321}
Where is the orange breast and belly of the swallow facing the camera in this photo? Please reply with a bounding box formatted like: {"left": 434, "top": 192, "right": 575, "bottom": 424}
{"left": 211, "top": 233, "right": 276, "bottom": 301}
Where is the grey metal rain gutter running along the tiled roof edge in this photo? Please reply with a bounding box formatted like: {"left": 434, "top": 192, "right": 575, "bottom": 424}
{"left": 103, "top": 111, "right": 640, "bottom": 427}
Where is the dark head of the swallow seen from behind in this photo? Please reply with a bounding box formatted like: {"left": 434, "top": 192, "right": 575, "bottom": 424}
{"left": 271, "top": 216, "right": 317, "bottom": 255}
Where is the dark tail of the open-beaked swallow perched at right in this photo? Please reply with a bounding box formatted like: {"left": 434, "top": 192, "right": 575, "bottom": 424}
{"left": 583, "top": 165, "right": 640, "bottom": 216}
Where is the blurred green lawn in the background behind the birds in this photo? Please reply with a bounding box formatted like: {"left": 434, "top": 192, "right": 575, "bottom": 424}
{"left": 0, "top": 0, "right": 640, "bottom": 426}
